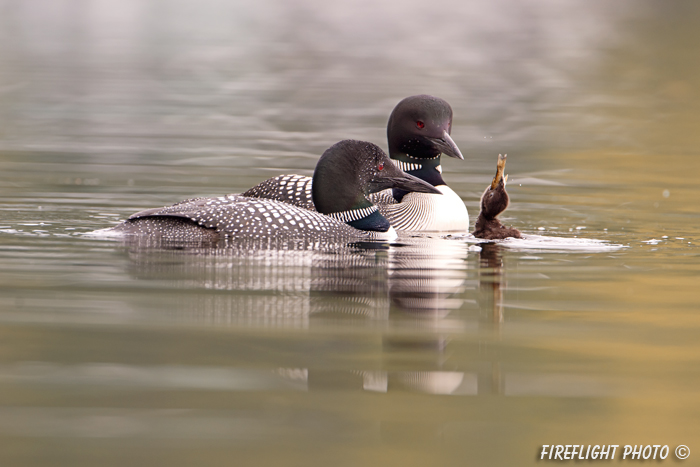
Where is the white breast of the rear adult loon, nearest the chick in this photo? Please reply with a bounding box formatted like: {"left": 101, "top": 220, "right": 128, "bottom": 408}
{"left": 377, "top": 185, "right": 469, "bottom": 233}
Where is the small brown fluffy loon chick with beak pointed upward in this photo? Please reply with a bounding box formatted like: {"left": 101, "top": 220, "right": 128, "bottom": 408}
{"left": 473, "top": 154, "right": 522, "bottom": 240}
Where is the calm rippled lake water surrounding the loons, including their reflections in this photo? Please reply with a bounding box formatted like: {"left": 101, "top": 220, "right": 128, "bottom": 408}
{"left": 0, "top": 0, "right": 700, "bottom": 466}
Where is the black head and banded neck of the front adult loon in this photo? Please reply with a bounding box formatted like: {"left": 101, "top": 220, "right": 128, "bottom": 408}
{"left": 311, "top": 140, "right": 440, "bottom": 232}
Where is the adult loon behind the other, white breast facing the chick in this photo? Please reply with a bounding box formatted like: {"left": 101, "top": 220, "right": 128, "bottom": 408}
{"left": 244, "top": 95, "right": 469, "bottom": 232}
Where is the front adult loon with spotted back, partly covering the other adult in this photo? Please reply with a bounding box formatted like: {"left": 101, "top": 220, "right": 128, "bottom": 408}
{"left": 108, "top": 140, "right": 437, "bottom": 241}
